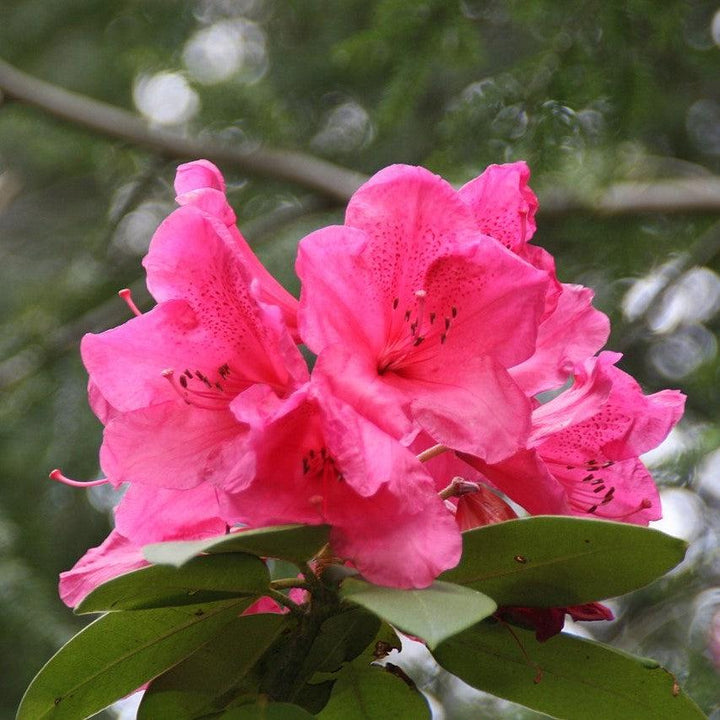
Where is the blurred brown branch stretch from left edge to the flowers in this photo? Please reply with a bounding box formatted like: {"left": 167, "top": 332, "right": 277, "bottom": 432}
{"left": 0, "top": 55, "right": 365, "bottom": 203}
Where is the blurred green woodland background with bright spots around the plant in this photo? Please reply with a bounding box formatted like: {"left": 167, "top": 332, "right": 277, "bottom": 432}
{"left": 0, "top": 0, "right": 720, "bottom": 720}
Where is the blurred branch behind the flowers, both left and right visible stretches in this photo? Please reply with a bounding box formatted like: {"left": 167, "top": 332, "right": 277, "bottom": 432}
{"left": 0, "top": 60, "right": 720, "bottom": 218}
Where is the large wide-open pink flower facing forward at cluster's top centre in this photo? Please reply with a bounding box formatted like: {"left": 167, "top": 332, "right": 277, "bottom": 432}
{"left": 297, "top": 165, "right": 549, "bottom": 460}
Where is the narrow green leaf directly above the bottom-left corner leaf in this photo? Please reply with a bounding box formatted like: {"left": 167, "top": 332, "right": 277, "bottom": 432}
{"left": 76, "top": 553, "right": 270, "bottom": 613}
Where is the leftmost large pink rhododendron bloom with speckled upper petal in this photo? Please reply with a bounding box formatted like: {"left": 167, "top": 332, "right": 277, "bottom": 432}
{"left": 82, "top": 188, "right": 307, "bottom": 488}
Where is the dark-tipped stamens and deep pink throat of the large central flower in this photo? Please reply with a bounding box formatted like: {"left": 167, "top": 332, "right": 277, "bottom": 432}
{"left": 377, "top": 290, "right": 458, "bottom": 375}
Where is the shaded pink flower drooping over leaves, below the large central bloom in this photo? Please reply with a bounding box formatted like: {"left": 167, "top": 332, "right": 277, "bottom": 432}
{"left": 222, "top": 383, "right": 461, "bottom": 587}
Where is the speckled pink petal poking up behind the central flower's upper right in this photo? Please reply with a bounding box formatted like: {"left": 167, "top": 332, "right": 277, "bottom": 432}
{"left": 459, "top": 161, "right": 538, "bottom": 252}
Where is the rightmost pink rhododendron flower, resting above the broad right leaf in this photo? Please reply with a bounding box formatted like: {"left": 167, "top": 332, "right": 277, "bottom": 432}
{"left": 465, "top": 352, "right": 684, "bottom": 525}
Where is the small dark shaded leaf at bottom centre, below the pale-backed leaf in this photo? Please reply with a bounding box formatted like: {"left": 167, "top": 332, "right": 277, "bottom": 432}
{"left": 303, "top": 607, "right": 380, "bottom": 675}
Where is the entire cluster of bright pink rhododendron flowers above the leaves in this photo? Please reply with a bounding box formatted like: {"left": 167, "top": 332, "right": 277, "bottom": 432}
{"left": 60, "top": 160, "right": 683, "bottom": 612}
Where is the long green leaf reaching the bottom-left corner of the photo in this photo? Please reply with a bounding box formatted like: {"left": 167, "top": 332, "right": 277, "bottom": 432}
{"left": 16, "top": 598, "right": 252, "bottom": 720}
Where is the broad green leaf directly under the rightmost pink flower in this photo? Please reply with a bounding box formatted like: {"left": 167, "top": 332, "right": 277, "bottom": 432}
{"left": 440, "top": 516, "right": 687, "bottom": 607}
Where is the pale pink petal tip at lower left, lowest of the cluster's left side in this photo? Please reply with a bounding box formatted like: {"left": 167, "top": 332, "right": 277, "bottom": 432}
{"left": 60, "top": 530, "right": 148, "bottom": 607}
